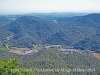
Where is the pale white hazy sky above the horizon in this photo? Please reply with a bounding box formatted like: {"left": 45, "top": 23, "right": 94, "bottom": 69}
{"left": 0, "top": 0, "right": 100, "bottom": 13}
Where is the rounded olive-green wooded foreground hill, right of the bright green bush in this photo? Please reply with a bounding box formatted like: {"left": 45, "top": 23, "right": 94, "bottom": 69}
{"left": 23, "top": 49, "right": 100, "bottom": 75}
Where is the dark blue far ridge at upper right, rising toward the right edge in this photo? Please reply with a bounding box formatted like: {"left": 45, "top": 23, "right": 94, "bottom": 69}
{"left": 57, "top": 14, "right": 100, "bottom": 27}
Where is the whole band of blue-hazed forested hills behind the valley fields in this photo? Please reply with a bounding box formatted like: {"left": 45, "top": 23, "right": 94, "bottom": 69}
{"left": 0, "top": 14, "right": 100, "bottom": 51}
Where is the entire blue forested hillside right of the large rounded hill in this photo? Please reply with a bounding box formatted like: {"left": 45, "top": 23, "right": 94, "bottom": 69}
{"left": 46, "top": 14, "right": 100, "bottom": 52}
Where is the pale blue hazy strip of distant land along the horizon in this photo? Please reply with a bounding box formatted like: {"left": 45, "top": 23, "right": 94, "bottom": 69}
{"left": 27, "top": 12, "right": 88, "bottom": 20}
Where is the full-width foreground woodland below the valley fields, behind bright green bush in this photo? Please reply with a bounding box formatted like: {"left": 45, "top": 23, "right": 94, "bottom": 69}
{"left": 0, "top": 48, "right": 100, "bottom": 75}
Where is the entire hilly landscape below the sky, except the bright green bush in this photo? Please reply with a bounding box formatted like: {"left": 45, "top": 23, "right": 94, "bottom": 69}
{"left": 0, "top": 13, "right": 100, "bottom": 75}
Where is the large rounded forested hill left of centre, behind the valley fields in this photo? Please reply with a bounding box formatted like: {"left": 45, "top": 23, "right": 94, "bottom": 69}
{"left": 3, "top": 16, "right": 59, "bottom": 47}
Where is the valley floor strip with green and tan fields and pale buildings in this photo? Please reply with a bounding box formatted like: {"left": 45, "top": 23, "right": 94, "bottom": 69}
{"left": 0, "top": 44, "right": 100, "bottom": 59}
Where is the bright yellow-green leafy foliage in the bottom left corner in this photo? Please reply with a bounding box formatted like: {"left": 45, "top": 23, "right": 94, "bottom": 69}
{"left": 0, "top": 59, "right": 34, "bottom": 75}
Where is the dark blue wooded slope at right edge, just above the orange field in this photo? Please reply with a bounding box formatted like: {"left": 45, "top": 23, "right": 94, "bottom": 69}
{"left": 75, "top": 34, "right": 100, "bottom": 53}
